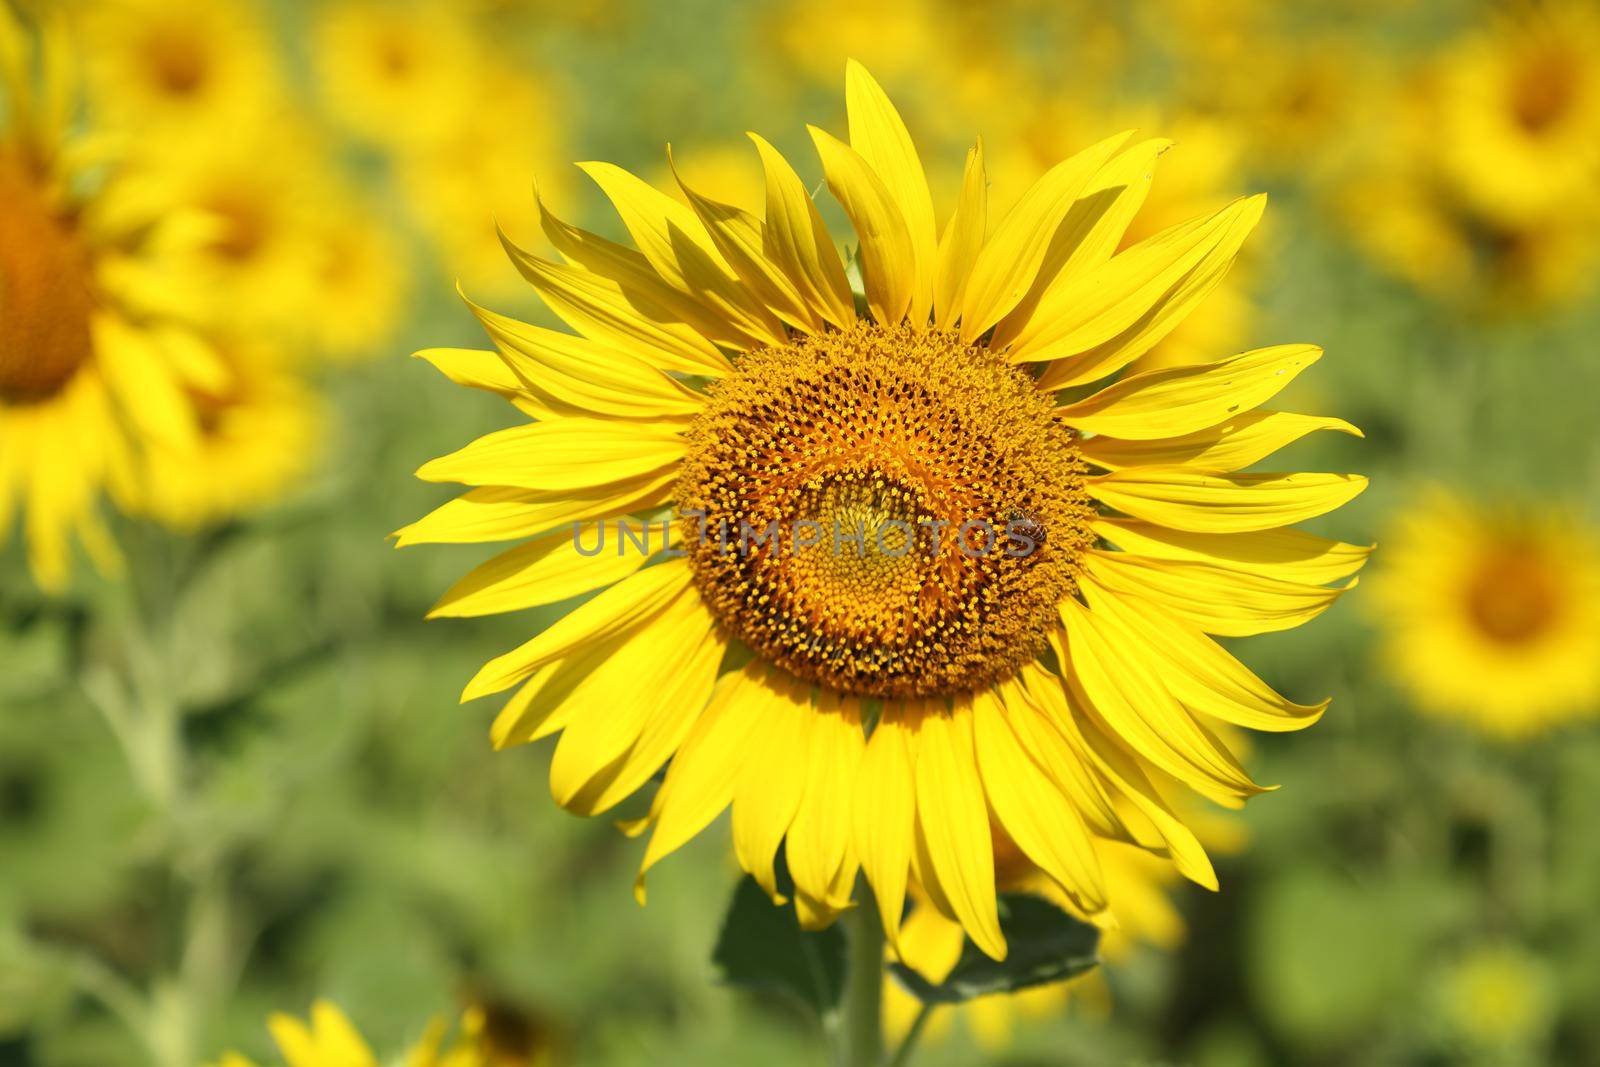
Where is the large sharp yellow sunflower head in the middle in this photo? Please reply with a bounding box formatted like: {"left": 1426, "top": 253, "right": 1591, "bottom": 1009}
{"left": 400, "top": 64, "right": 1366, "bottom": 957}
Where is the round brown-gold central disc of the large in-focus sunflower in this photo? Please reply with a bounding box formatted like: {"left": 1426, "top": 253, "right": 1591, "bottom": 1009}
{"left": 678, "top": 325, "right": 1093, "bottom": 697}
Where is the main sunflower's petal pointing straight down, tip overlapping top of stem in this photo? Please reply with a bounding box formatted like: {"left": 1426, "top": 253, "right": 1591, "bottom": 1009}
{"left": 854, "top": 704, "right": 917, "bottom": 950}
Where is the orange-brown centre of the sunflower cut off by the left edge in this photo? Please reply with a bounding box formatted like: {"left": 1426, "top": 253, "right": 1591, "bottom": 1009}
{"left": 0, "top": 152, "right": 93, "bottom": 403}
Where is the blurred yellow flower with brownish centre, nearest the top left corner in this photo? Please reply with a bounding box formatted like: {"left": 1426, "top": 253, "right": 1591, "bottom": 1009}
{"left": 80, "top": 0, "right": 283, "bottom": 141}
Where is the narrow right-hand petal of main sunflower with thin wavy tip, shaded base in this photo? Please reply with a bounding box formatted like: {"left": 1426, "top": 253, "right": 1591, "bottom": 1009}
{"left": 1078, "top": 411, "right": 1362, "bottom": 472}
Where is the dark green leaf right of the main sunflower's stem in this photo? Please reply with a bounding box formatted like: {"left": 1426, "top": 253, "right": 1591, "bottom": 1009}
{"left": 890, "top": 894, "right": 1099, "bottom": 1005}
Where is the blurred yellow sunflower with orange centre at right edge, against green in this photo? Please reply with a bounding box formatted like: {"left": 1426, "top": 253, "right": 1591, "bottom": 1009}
{"left": 1371, "top": 491, "right": 1600, "bottom": 737}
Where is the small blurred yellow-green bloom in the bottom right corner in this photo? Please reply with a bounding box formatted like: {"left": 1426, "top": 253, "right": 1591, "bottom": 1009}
{"left": 1437, "top": 945, "right": 1558, "bottom": 1062}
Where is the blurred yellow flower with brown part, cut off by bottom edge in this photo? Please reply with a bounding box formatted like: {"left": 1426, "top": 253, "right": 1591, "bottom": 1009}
{"left": 216, "top": 1000, "right": 557, "bottom": 1067}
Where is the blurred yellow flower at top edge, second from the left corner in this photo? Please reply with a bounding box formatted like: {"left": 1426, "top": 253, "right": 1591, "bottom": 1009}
{"left": 315, "top": 0, "right": 483, "bottom": 149}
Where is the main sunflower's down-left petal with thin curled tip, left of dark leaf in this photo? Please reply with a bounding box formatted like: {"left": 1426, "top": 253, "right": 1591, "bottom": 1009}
{"left": 634, "top": 659, "right": 766, "bottom": 904}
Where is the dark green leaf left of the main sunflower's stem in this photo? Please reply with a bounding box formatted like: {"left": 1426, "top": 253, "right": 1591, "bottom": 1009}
{"left": 712, "top": 878, "right": 845, "bottom": 1019}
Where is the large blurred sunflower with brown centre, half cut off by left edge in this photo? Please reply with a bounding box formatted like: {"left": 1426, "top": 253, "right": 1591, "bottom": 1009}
{"left": 0, "top": 5, "right": 213, "bottom": 587}
